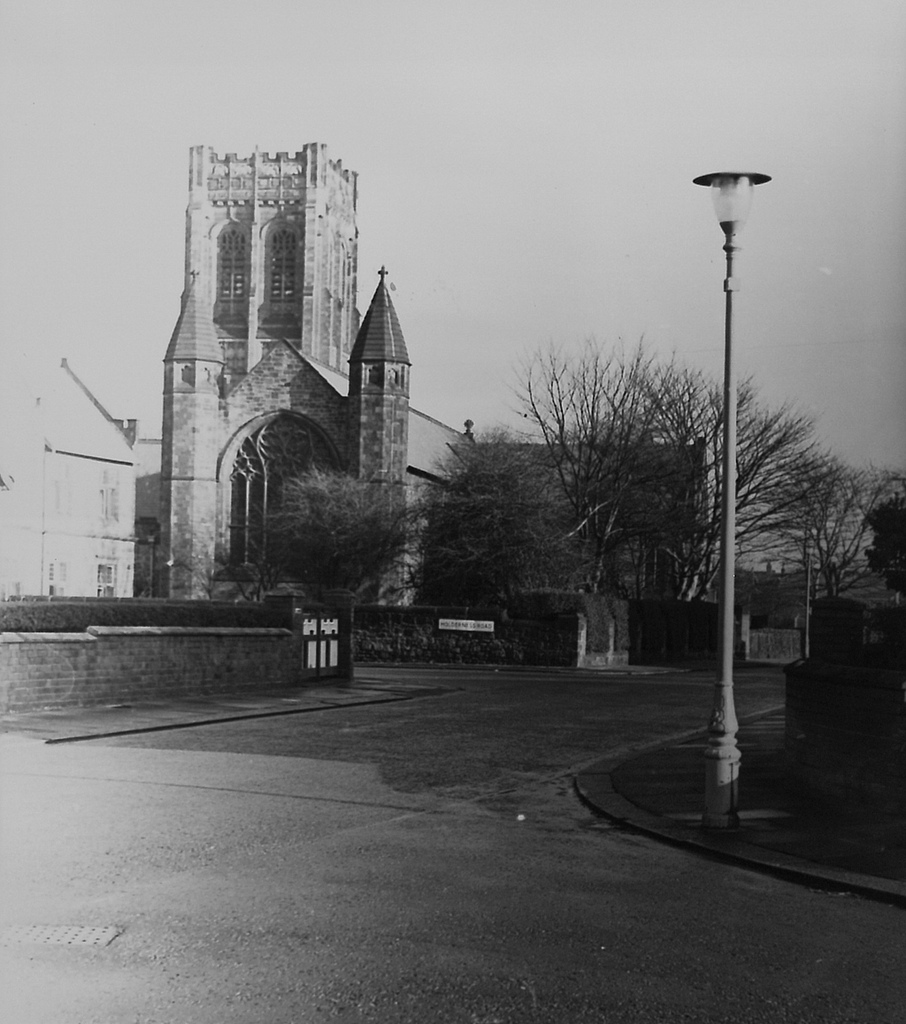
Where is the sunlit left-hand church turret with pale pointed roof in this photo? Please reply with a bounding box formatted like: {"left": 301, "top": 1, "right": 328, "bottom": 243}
{"left": 161, "top": 279, "right": 223, "bottom": 598}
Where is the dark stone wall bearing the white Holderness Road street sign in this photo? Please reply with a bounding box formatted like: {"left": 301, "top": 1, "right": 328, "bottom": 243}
{"left": 353, "top": 605, "right": 586, "bottom": 667}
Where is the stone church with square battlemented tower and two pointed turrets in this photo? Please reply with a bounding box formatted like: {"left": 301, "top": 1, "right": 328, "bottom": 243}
{"left": 159, "top": 143, "right": 468, "bottom": 598}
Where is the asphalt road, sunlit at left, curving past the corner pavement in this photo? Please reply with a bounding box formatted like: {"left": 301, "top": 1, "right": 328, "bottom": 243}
{"left": 0, "top": 669, "right": 906, "bottom": 1024}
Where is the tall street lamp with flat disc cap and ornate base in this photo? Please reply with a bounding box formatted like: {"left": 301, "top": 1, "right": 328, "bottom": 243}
{"left": 693, "top": 171, "right": 771, "bottom": 828}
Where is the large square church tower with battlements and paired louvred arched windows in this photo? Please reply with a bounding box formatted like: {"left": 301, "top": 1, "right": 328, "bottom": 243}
{"left": 185, "top": 142, "right": 358, "bottom": 386}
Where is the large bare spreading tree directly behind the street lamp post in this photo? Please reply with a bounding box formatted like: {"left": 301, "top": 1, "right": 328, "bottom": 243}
{"left": 520, "top": 342, "right": 815, "bottom": 600}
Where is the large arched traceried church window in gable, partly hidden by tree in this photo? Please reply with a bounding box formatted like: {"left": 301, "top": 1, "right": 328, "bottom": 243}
{"left": 229, "top": 415, "right": 334, "bottom": 565}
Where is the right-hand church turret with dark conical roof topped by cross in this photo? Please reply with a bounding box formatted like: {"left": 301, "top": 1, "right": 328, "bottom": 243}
{"left": 349, "top": 267, "right": 412, "bottom": 487}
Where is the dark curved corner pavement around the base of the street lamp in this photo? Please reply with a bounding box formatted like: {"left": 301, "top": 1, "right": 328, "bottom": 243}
{"left": 574, "top": 708, "right": 906, "bottom": 906}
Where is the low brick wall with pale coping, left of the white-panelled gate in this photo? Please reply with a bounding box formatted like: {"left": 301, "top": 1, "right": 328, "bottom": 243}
{"left": 0, "top": 627, "right": 299, "bottom": 713}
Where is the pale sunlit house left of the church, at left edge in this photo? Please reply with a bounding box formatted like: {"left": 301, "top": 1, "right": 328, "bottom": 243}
{"left": 0, "top": 359, "right": 135, "bottom": 600}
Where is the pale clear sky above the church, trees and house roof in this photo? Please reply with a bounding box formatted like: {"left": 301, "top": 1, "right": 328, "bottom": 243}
{"left": 0, "top": 0, "right": 906, "bottom": 472}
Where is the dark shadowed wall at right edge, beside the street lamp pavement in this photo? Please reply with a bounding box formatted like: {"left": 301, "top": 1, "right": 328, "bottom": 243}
{"left": 784, "top": 662, "right": 906, "bottom": 814}
